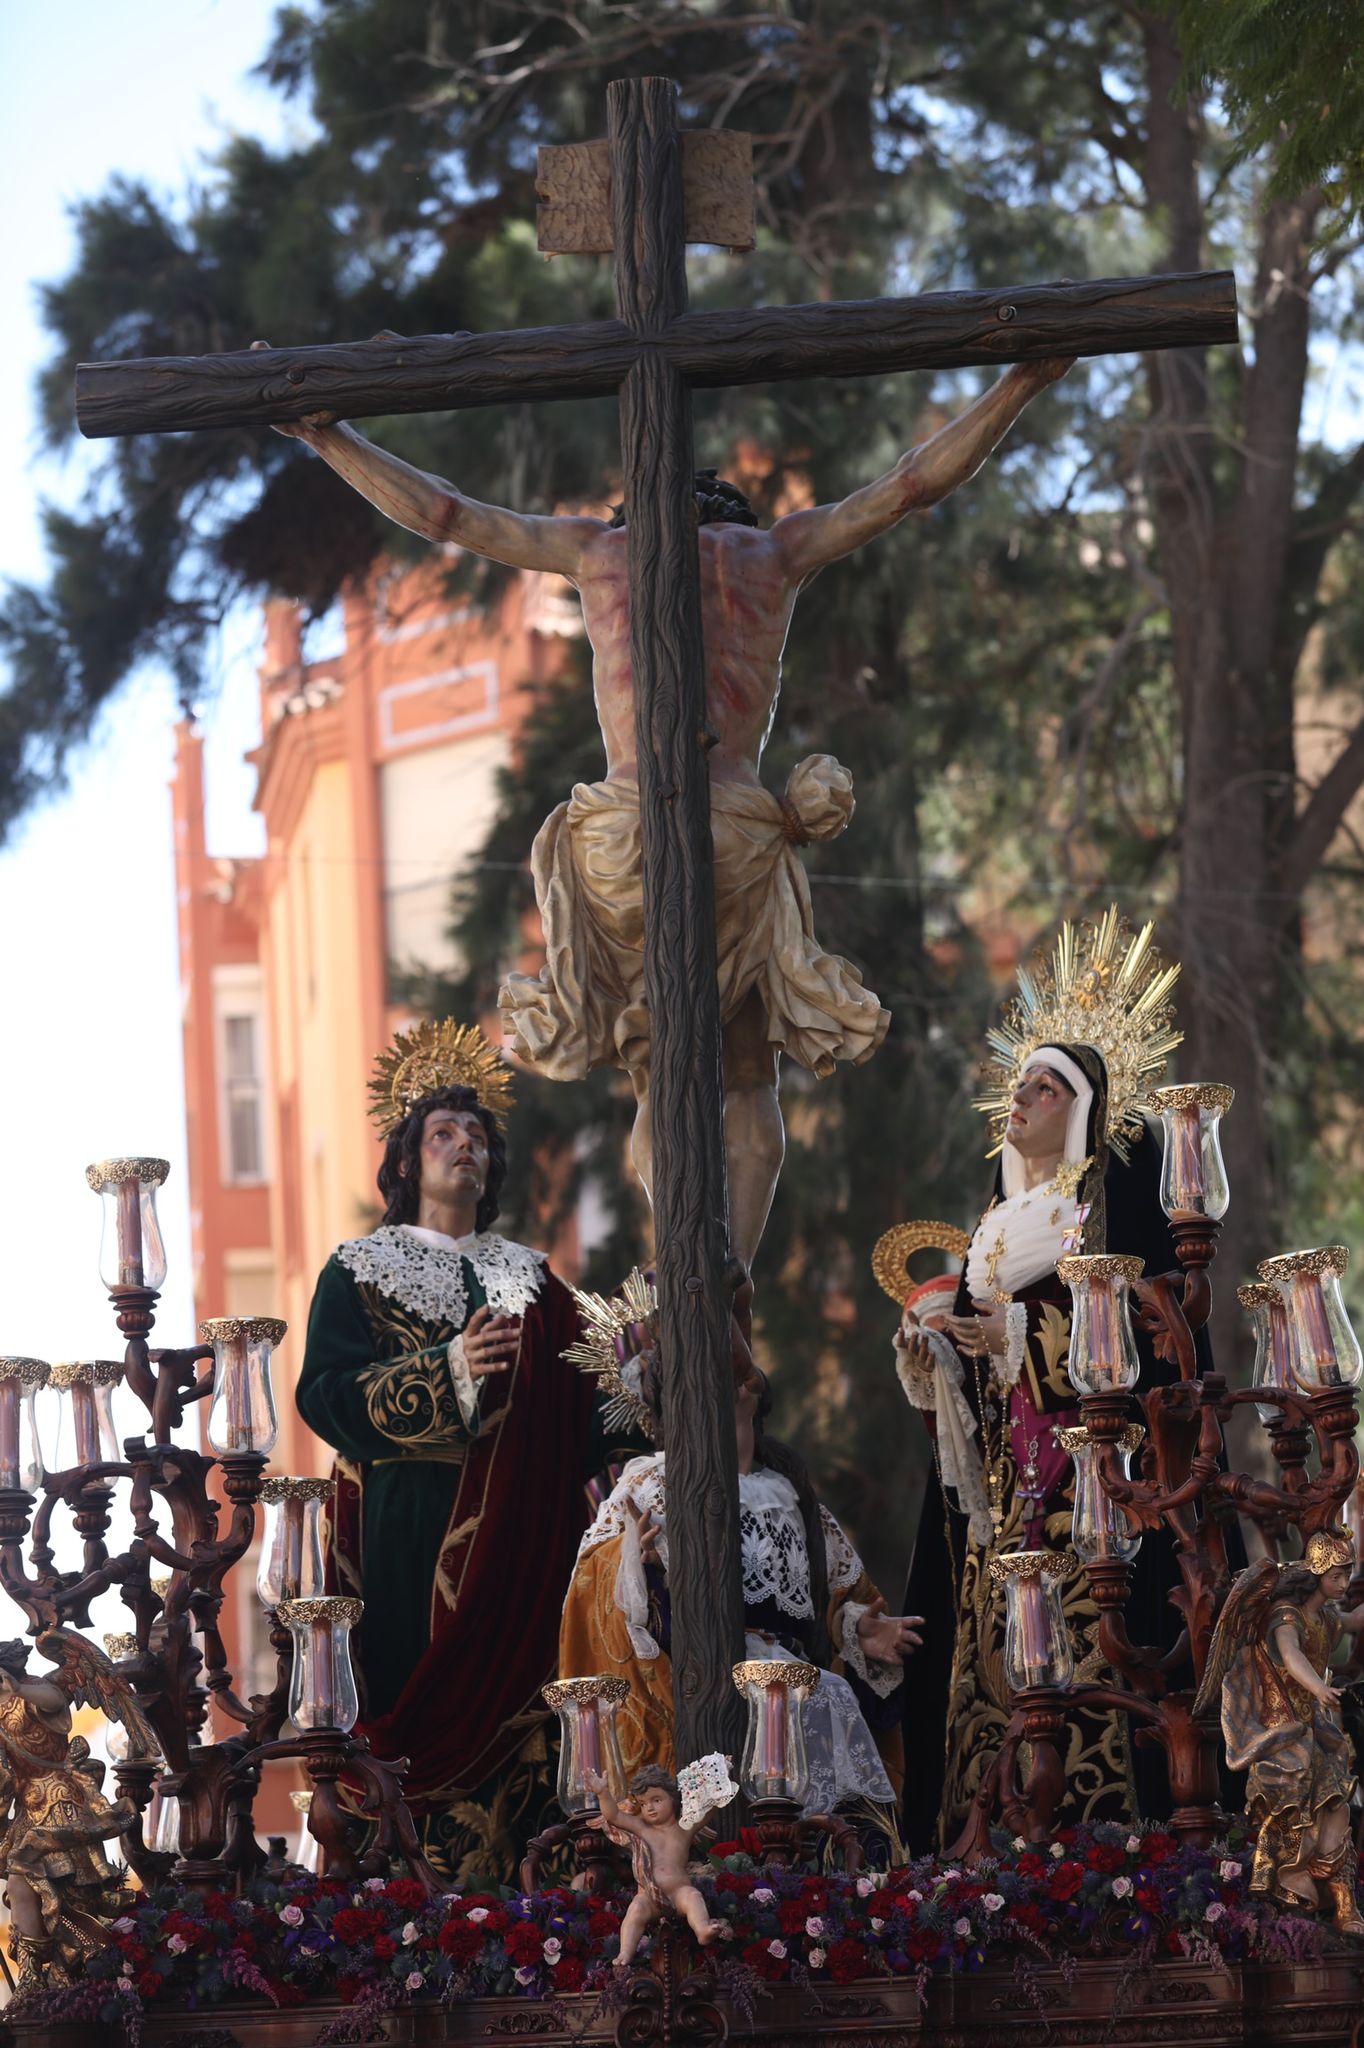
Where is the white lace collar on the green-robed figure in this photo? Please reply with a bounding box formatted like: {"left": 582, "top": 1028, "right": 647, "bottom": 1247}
{"left": 336, "top": 1223, "right": 545, "bottom": 1331}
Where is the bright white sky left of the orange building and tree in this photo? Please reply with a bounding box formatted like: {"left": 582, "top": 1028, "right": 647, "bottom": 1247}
{"left": 0, "top": 0, "right": 285, "bottom": 1634}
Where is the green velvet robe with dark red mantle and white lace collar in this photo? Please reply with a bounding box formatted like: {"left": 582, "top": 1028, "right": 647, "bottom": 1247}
{"left": 297, "top": 1227, "right": 606, "bottom": 1884}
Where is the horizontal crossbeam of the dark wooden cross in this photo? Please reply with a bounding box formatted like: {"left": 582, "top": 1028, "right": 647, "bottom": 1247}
{"left": 76, "top": 270, "right": 1237, "bottom": 440}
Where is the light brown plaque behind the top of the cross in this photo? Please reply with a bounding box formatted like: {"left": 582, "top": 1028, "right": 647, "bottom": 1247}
{"left": 535, "top": 129, "right": 758, "bottom": 256}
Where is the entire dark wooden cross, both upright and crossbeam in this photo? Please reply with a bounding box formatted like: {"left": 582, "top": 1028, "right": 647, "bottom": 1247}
{"left": 76, "top": 78, "right": 1237, "bottom": 1761}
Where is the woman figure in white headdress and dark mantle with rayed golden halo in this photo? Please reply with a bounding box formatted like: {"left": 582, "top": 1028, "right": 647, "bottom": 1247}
{"left": 895, "top": 909, "right": 1180, "bottom": 1851}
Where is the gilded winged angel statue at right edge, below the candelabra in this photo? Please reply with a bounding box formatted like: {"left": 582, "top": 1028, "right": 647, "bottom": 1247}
{"left": 1194, "top": 1530, "right": 1364, "bottom": 1935}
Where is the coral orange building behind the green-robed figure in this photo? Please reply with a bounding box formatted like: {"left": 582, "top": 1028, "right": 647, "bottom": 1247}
{"left": 174, "top": 559, "right": 580, "bottom": 1736}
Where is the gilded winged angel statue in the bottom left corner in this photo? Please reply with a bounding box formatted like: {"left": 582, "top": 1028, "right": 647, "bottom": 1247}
{"left": 0, "top": 1628, "right": 156, "bottom": 1991}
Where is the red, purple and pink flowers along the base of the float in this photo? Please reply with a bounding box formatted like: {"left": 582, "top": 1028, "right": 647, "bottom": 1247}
{"left": 13, "top": 1823, "right": 1333, "bottom": 2040}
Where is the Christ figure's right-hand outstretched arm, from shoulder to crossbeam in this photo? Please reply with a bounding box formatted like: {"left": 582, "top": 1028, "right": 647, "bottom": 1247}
{"left": 772, "top": 356, "right": 1073, "bottom": 584}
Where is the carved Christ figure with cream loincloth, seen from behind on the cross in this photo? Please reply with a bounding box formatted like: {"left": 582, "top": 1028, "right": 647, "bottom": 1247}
{"left": 270, "top": 360, "right": 1069, "bottom": 1266}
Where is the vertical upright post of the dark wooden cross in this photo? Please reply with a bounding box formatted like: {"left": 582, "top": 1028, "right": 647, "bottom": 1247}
{"left": 608, "top": 78, "right": 743, "bottom": 1763}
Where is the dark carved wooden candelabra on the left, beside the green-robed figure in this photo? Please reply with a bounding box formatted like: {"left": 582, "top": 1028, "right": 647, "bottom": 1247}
{"left": 0, "top": 1236, "right": 436, "bottom": 1892}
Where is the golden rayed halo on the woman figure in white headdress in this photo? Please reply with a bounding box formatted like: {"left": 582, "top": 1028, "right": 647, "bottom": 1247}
{"left": 975, "top": 903, "right": 1184, "bottom": 1159}
